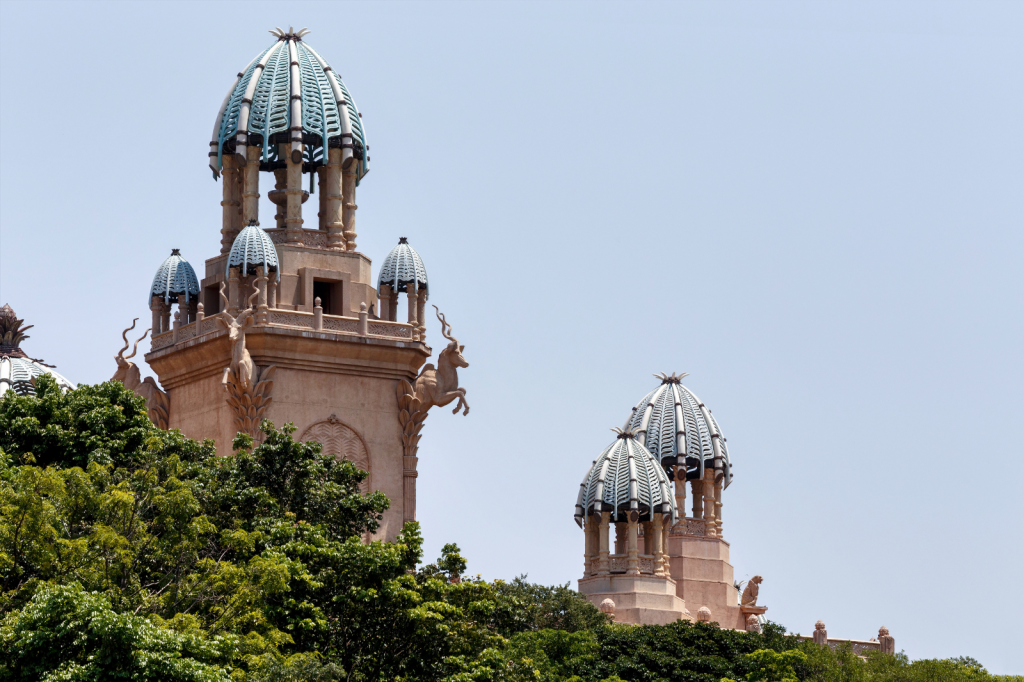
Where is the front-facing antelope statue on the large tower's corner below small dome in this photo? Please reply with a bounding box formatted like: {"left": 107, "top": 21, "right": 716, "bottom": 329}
{"left": 216, "top": 283, "right": 278, "bottom": 440}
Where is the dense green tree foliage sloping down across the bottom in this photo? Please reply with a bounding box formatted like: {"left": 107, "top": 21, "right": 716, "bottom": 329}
{"left": 0, "top": 377, "right": 1019, "bottom": 682}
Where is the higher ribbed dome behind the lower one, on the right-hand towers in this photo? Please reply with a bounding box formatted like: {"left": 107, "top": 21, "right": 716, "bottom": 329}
{"left": 623, "top": 373, "right": 732, "bottom": 487}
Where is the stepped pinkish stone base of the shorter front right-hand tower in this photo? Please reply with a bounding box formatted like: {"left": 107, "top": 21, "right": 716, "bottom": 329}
{"left": 580, "top": 576, "right": 692, "bottom": 625}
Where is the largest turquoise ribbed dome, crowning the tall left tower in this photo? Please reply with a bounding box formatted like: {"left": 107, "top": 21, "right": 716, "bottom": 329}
{"left": 210, "top": 29, "right": 370, "bottom": 181}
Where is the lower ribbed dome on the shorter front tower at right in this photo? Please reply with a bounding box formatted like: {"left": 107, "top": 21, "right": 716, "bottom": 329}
{"left": 575, "top": 431, "right": 677, "bottom": 524}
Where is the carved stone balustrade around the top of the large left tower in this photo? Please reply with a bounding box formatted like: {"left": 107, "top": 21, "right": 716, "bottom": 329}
{"left": 152, "top": 309, "right": 413, "bottom": 350}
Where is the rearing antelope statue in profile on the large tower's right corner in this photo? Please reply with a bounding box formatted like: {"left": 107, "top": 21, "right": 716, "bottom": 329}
{"left": 397, "top": 305, "right": 469, "bottom": 457}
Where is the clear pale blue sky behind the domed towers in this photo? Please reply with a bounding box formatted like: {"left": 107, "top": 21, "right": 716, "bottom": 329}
{"left": 0, "top": 1, "right": 1024, "bottom": 673}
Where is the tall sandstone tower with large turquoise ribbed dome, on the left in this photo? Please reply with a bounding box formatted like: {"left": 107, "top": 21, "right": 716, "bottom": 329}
{"left": 145, "top": 29, "right": 430, "bottom": 539}
